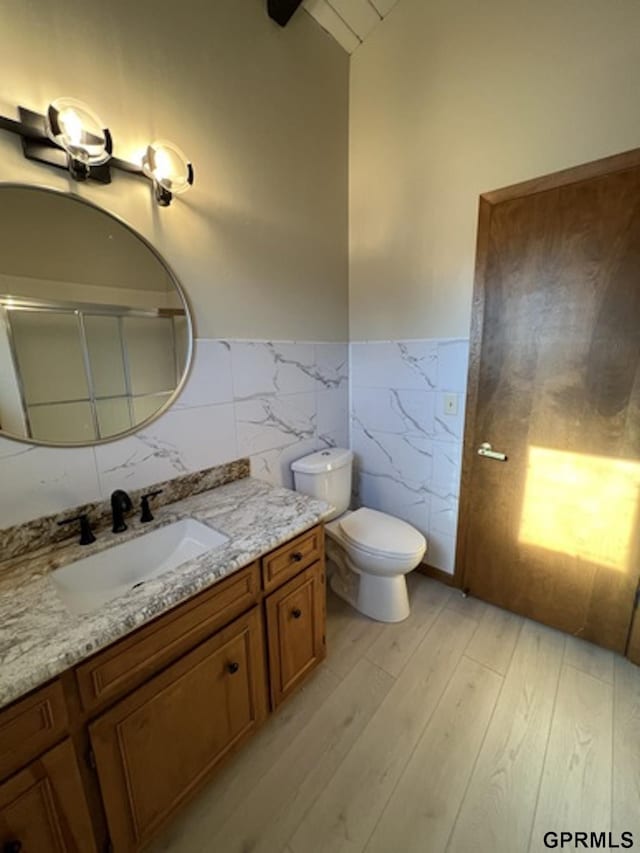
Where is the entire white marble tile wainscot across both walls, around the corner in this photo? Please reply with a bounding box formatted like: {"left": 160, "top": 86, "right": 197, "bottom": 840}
{"left": 0, "top": 332, "right": 468, "bottom": 571}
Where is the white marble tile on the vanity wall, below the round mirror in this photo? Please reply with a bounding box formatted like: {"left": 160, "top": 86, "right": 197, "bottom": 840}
{"left": 0, "top": 339, "right": 348, "bottom": 529}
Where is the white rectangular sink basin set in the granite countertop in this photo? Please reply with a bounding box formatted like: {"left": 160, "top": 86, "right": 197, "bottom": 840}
{"left": 51, "top": 518, "right": 229, "bottom": 614}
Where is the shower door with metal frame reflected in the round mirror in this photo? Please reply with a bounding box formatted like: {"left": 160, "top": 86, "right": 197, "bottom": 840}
{"left": 2, "top": 300, "right": 187, "bottom": 443}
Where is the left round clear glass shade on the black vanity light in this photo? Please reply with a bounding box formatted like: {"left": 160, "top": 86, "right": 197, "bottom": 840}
{"left": 47, "top": 98, "right": 111, "bottom": 166}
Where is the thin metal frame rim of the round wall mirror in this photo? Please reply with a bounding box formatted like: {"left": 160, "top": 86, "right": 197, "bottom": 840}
{"left": 0, "top": 181, "right": 194, "bottom": 450}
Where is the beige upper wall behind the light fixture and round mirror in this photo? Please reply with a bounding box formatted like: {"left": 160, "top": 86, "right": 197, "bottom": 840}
{"left": 0, "top": 0, "right": 348, "bottom": 340}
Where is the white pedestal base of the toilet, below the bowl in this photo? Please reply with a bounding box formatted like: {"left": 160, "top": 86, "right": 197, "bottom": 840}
{"left": 329, "top": 548, "right": 410, "bottom": 622}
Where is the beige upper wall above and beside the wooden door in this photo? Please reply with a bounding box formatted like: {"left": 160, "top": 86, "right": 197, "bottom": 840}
{"left": 350, "top": 0, "right": 640, "bottom": 340}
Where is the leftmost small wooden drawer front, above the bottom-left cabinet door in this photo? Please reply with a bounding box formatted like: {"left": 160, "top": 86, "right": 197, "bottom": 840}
{"left": 0, "top": 681, "right": 67, "bottom": 777}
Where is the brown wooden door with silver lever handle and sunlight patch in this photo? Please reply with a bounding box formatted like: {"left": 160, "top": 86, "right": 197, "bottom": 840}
{"left": 457, "top": 152, "right": 640, "bottom": 651}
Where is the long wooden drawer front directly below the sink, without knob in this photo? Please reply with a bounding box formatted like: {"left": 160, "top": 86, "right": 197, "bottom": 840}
{"left": 76, "top": 563, "right": 260, "bottom": 711}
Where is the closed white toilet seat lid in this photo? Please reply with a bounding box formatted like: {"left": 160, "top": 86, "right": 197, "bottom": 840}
{"left": 339, "top": 507, "right": 426, "bottom": 560}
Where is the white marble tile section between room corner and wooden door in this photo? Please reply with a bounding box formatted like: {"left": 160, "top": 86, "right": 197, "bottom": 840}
{"left": 350, "top": 339, "right": 469, "bottom": 572}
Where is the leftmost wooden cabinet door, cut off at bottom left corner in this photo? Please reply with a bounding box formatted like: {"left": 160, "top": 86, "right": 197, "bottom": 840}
{"left": 0, "top": 740, "right": 96, "bottom": 853}
